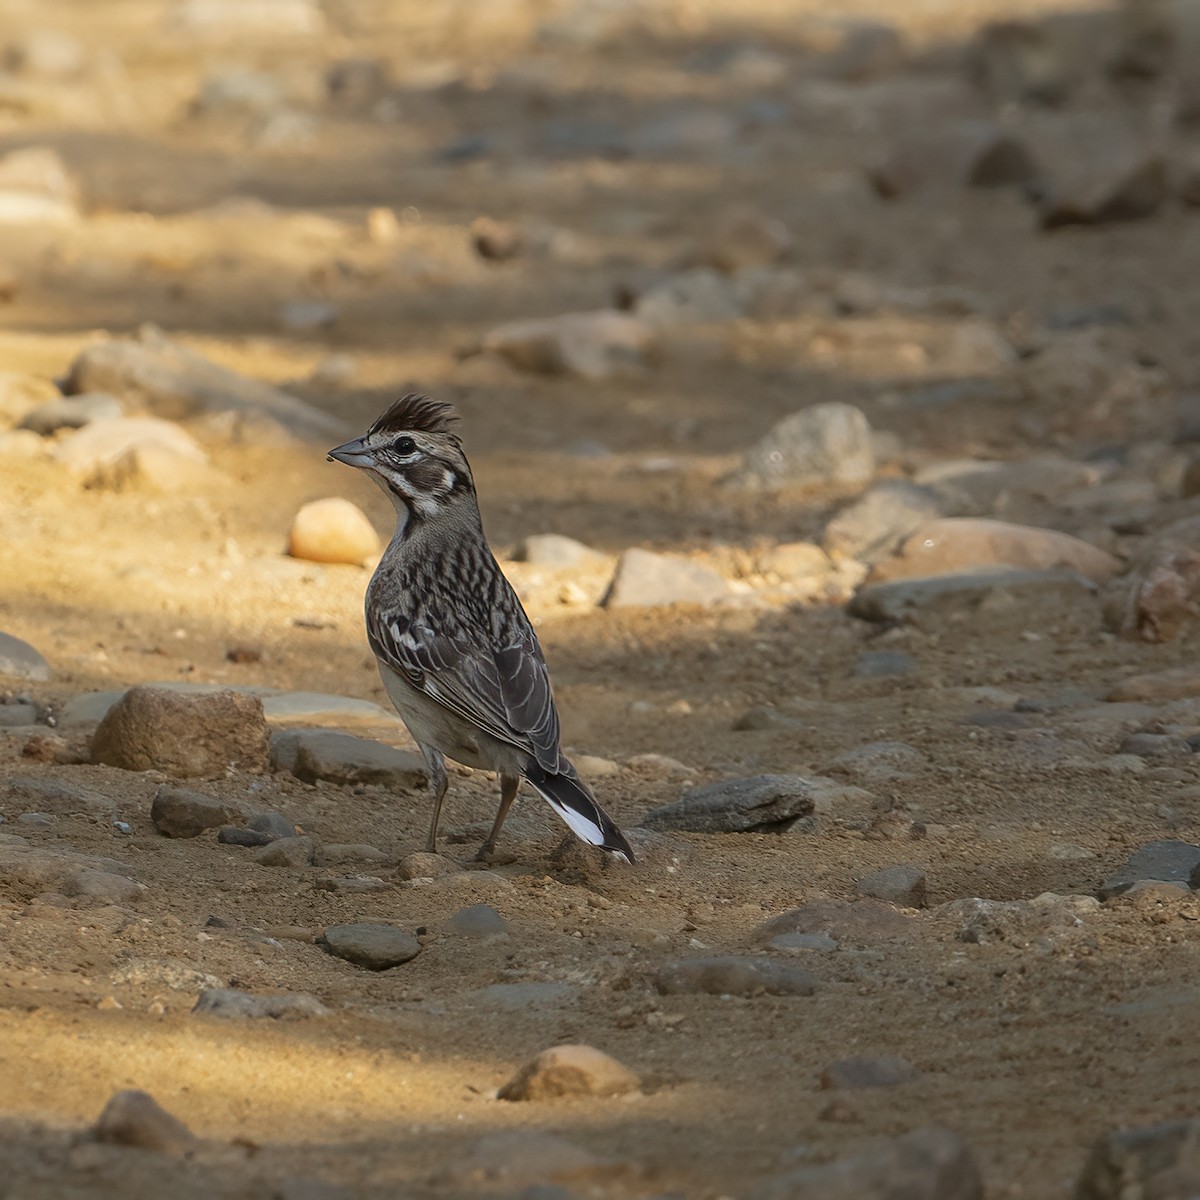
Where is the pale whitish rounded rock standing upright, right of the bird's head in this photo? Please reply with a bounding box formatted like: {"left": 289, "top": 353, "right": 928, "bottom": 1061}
{"left": 728, "top": 404, "right": 875, "bottom": 492}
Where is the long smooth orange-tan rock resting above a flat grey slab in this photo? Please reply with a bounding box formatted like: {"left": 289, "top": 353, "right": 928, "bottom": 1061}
{"left": 869, "top": 517, "right": 1121, "bottom": 583}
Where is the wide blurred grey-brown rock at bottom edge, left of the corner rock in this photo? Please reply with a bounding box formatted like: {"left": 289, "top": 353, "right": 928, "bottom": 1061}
{"left": 746, "top": 1126, "right": 983, "bottom": 1200}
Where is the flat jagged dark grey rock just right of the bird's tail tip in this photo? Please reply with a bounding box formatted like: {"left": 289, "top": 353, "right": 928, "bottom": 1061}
{"left": 643, "top": 775, "right": 838, "bottom": 833}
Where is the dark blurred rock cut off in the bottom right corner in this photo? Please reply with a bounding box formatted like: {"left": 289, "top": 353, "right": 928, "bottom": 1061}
{"left": 1073, "top": 1118, "right": 1200, "bottom": 1200}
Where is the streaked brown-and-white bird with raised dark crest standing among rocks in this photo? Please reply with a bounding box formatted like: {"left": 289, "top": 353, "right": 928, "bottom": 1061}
{"left": 329, "top": 392, "right": 635, "bottom": 863}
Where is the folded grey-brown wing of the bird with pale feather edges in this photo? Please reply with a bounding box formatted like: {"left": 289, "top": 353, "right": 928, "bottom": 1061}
{"left": 367, "top": 604, "right": 559, "bottom": 772}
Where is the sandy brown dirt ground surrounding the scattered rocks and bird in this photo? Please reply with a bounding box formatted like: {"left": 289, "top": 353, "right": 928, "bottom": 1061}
{"left": 0, "top": 0, "right": 1200, "bottom": 1200}
